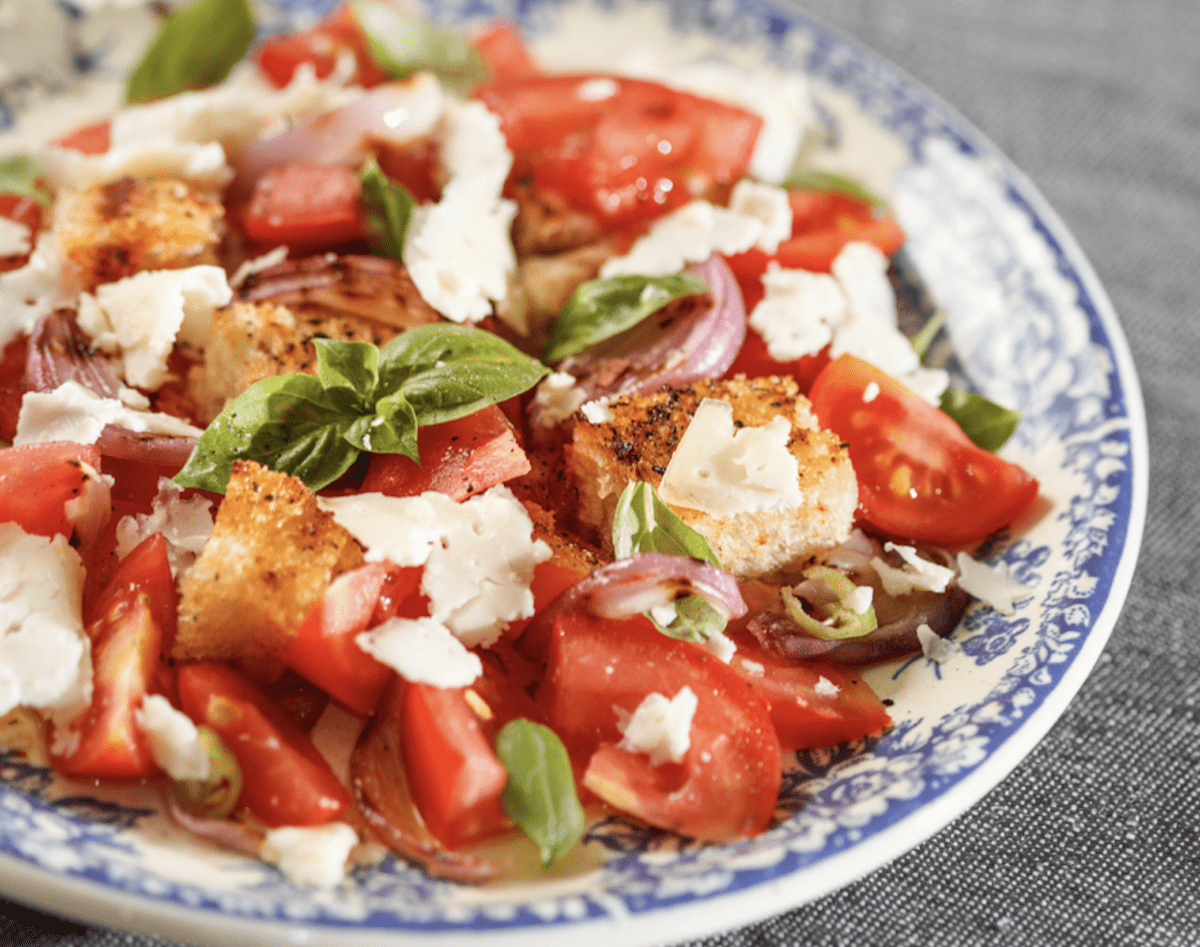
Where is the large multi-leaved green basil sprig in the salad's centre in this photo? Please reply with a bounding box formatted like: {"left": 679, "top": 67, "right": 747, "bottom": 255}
{"left": 175, "top": 323, "right": 550, "bottom": 493}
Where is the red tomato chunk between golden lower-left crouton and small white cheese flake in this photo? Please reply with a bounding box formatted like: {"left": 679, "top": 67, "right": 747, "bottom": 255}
{"left": 283, "top": 563, "right": 421, "bottom": 714}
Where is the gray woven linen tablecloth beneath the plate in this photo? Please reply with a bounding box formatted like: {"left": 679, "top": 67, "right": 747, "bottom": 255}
{"left": 0, "top": 0, "right": 1200, "bottom": 947}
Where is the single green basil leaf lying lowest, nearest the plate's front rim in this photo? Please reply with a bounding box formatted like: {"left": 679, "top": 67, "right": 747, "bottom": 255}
{"left": 496, "top": 719, "right": 584, "bottom": 864}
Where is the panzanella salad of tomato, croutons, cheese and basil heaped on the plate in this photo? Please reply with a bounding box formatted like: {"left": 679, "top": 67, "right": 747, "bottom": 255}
{"left": 0, "top": 0, "right": 1038, "bottom": 886}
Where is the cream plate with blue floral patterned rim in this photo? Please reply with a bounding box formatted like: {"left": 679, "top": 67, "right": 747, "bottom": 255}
{"left": 0, "top": 0, "right": 1148, "bottom": 947}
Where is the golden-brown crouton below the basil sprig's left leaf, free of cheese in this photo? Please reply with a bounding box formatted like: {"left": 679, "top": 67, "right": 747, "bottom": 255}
{"left": 173, "top": 461, "right": 362, "bottom": 681}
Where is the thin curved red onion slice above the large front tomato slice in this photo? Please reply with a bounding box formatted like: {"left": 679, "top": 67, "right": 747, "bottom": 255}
{"left": 522, "top": 552, "right": 746, "bottom": 642}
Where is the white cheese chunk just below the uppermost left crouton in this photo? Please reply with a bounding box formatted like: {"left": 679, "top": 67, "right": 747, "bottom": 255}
{"left": 78, "top": 264, "right": 233, "bottom": 391}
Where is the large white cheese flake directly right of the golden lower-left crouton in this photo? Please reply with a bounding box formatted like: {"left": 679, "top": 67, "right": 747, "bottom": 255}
{"left": 318, "top": 486, "right": 551, "bottom": 648}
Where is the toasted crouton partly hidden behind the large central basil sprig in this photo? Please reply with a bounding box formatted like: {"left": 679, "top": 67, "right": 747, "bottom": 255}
{"left": 188, "top": 302, "right": 400, "bottom": 421}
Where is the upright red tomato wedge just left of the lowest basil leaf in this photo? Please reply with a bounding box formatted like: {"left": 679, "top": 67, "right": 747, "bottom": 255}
{"left": 401, "top": 683, "right": 509, "bottom": 849}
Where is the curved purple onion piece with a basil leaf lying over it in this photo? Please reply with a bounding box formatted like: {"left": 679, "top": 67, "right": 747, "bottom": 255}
{"left": 559, "top": 253, "right": 746, "bottom": 400}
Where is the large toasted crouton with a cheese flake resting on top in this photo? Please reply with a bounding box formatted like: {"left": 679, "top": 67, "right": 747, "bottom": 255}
{"left": 570, "top": 377, "right": 858, "bottom": 579}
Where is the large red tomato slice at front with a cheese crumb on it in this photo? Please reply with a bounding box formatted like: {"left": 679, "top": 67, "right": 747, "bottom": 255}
{"left": 538, "top": 613, "right": 781, "bottom": 841}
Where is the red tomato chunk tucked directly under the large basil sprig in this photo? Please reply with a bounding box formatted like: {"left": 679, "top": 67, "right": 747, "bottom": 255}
{"left": 362, "top": 404, "right": 529, "bottom": 502}
